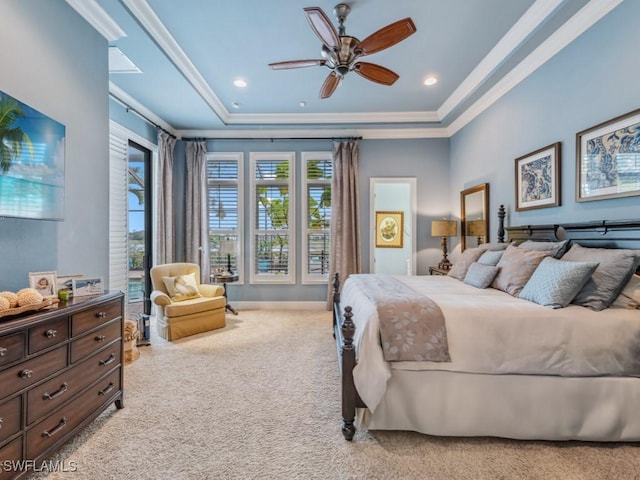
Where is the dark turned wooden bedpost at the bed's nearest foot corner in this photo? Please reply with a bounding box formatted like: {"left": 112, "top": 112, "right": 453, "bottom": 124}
{"left": 340, "top": 307, "right": 356, "bottom": 440}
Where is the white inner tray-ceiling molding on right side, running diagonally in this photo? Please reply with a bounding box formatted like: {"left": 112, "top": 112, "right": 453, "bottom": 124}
{"left": 438, "top": 0, "right": 563, "bottom": 119}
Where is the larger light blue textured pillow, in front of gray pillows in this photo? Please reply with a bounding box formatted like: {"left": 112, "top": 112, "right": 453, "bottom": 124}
{"left": 520, "top": 257, "right": 598, "bottom": 308}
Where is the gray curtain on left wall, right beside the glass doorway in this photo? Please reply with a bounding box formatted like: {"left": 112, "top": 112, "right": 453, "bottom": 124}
{"left": 155, "top": 131, "right": 176, "bottom": 265}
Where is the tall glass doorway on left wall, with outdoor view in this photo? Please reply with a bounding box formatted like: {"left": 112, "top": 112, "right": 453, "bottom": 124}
{"left": 127, "top": 140, "right": 152, "bottom": 315}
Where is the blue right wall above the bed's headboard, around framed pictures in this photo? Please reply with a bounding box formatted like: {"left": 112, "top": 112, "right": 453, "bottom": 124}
{"left": 450, "top": 1, "right": 640, "bottom": 253}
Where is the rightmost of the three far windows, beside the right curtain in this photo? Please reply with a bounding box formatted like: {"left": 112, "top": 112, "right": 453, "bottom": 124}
{"left": 301, "top": 152, "right": 333, "bottom": 283}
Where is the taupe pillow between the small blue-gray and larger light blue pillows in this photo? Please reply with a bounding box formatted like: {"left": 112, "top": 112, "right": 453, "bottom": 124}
{"left": 491, "top": 245, "right": 549, "bottom": 297}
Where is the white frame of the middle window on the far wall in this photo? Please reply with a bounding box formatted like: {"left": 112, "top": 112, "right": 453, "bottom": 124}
{"left": 249, "top": 152, "right": 296, "bottom": 285}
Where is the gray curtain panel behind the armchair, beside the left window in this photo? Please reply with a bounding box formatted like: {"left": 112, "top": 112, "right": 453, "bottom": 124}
{"left": 184, "top": 142, "right": 211, "bottom": 283}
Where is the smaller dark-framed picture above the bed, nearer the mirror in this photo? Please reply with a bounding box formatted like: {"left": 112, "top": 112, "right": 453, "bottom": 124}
{"left": 515, "top": 142, "right": 560, "bottom": 212}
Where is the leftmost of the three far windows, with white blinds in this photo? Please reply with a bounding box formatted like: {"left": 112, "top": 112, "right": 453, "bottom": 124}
{"left": 207, "top": 153, "right": 244, "bottom": 281}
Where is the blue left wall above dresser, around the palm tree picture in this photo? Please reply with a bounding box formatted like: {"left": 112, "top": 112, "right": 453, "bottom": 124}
{"left": 0, "top": 0, "right": 109, "bottom": 291}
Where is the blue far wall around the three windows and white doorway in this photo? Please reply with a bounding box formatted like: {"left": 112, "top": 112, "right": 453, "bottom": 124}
{"left": 174, "top": 139, "right": 450, "bottom": 301}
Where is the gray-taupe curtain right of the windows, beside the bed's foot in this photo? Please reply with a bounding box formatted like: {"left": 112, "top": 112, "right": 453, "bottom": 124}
{"left": 327, "top": 140, "right": 362, "bottom": 310}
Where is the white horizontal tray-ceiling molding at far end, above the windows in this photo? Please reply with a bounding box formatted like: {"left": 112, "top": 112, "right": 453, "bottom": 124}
{"left": 227, "top": 112, "right": 440, "bottom": 124}
